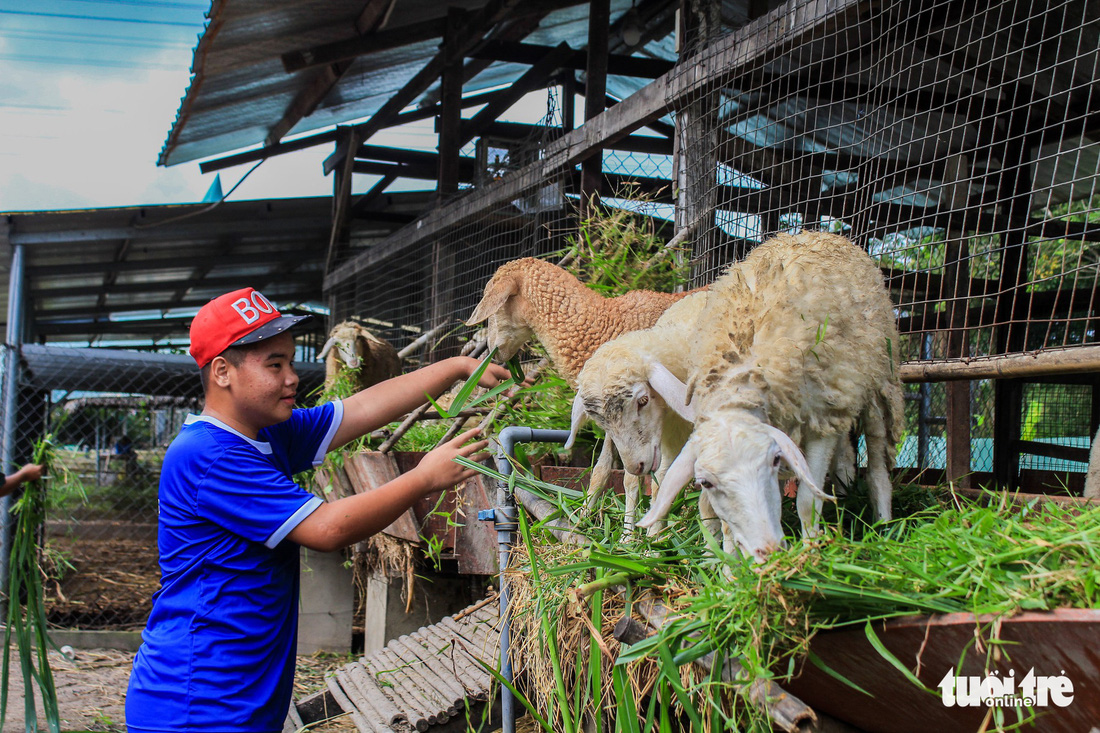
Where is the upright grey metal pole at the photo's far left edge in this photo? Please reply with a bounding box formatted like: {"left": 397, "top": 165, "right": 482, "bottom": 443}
{"left": 0, "top": 244, "right": 25, "bottom": 607}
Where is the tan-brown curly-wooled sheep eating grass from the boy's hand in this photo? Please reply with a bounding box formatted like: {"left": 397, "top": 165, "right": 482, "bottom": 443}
{"left": 466, "top": 258, "right": 704, "bottom": 508}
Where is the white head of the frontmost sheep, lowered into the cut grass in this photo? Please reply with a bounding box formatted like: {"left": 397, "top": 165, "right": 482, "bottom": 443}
{"left": 638, "top": 413, "right": 834, "bottom": 562}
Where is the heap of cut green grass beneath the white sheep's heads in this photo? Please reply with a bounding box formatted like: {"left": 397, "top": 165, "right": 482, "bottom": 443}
{"left": 459, "top": 453, "right": 1100, "bottom": 733}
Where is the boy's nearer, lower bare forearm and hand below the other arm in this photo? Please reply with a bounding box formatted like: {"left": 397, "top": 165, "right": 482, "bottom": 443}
{"left": 287, "top": 424, "right": 487, "bottom": 553}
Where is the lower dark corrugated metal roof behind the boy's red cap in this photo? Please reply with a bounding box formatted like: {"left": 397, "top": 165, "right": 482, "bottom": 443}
{"left": 0, "top": 194, "right": 424, "bottom": 346}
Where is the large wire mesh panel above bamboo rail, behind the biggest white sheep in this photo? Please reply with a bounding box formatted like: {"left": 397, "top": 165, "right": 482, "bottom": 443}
{"left": 671, "top": 0, "right": 1100, "bottom": 361}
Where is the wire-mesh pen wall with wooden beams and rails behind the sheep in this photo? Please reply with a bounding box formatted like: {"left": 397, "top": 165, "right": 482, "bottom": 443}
{"left": 326, "top": 0, "right": 1100, "bottom": 491}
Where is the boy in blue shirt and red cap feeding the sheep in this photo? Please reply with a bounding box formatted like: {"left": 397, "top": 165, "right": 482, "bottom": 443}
{"left": 127, "top": 288, "right": 508, "bottom": 733}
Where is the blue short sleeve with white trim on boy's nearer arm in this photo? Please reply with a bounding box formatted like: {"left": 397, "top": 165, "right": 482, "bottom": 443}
{"left": 197, "top": 446, "right": 321, "bottom": 547}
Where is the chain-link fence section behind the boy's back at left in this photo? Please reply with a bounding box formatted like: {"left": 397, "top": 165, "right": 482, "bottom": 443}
{"left": 6, "top": 346, "right": 201, "bottom": 630}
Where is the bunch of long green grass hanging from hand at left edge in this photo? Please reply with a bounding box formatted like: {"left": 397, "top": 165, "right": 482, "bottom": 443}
{"left": 0, "top": 436, "right": 61, "bottom": 733}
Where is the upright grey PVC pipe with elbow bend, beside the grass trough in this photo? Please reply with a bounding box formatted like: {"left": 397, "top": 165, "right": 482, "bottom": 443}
{"left": 496, "top": 427, "right": 569, "bottom": 733}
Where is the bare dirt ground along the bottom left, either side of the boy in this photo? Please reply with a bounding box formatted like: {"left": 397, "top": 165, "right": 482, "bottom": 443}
{"left": 3, "top": 648, "right": 358, "bottom": 733}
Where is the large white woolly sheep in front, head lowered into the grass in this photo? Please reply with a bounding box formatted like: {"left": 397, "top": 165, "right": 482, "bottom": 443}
{"left": 639, "top": 232, "right": 902, "bottom": 560}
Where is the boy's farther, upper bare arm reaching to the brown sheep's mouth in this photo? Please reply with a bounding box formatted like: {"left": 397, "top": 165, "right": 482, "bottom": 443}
{"left": 329, "top": 357, "right": 509, "bottom": 449}
